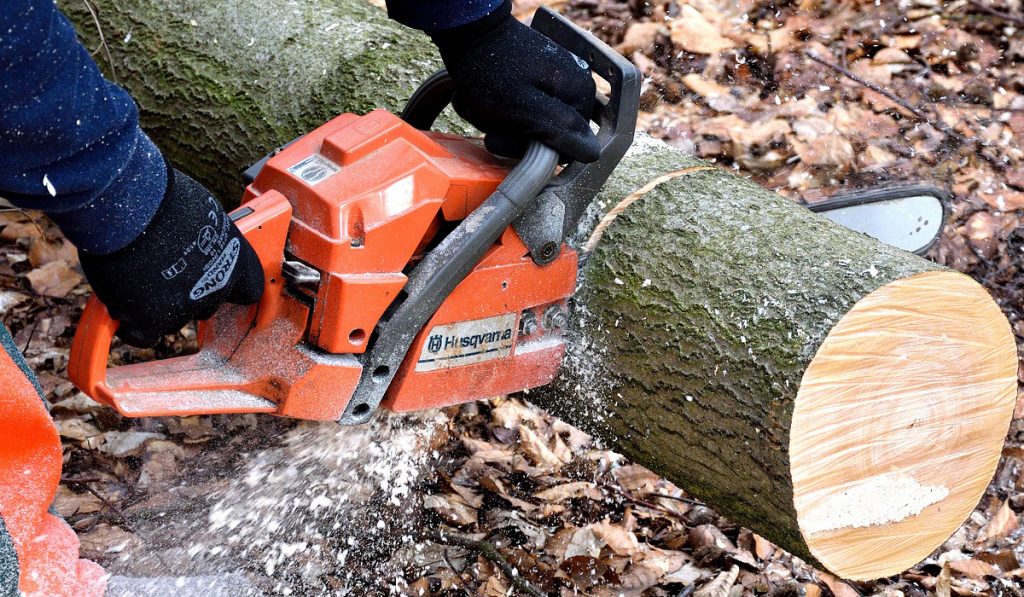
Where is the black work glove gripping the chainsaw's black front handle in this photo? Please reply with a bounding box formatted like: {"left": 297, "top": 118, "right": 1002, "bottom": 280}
{"left": 430, "top": 0, "right": 600, "bottom": 163}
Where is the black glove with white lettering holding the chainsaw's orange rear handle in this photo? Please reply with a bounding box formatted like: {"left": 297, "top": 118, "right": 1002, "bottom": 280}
{"left": 79, "top": 165, "right": 263, "bottom": 347}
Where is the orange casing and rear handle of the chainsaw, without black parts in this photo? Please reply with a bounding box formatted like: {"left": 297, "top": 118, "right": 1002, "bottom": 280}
{"left": 69, "top": 111, "right": 577, "bottom": 420}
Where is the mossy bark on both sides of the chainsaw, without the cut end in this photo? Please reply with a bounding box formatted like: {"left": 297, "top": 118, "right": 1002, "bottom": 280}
{"left": 62, "top": 0, "right": 950, "bottom": 569}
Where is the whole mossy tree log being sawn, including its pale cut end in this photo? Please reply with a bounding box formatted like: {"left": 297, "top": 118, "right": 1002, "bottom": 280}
{"left": 63, "top": 0, "right": 1017, "bottom": 579}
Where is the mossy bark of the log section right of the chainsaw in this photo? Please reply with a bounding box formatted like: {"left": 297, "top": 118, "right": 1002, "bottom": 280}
{"left": 531, "top": 141, "right": 940, "bottom": 561}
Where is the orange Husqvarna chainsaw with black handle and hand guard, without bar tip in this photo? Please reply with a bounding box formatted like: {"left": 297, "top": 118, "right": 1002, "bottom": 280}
{"left": 68, "top": 7, "right": 640, "bottom": 424}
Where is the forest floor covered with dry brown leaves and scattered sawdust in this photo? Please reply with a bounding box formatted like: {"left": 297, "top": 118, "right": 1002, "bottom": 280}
{"left": 0, "top": 0, "right": 1024, "bottom": 597}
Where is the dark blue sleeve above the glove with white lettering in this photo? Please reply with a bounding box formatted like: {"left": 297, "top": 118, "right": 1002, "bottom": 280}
{"left": 0, "top": 0, "right": 167, "bottom": 253}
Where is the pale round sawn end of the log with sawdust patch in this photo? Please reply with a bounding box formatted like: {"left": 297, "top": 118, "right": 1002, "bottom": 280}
{"left": 790, "top": 271, "right": 1017, "bottom": 580}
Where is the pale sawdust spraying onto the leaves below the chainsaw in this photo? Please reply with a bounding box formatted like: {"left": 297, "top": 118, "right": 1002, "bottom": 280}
{"left": 101, "top": 411, "right": 446, "bottom": 597}
